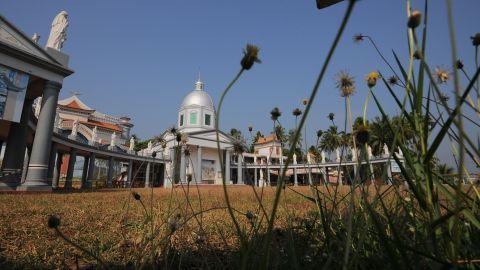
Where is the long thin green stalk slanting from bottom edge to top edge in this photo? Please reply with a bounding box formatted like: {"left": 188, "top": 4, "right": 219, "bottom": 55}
{"left": 261, "top": 0, "right": 356, "bottom": 269}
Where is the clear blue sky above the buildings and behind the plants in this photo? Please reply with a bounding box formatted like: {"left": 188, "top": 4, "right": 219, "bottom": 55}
{"left": 0, "top": 0, "right": 480, "bottom": 171}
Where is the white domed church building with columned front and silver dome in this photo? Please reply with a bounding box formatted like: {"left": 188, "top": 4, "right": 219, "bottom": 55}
{"left": 152, "top": 79, "right": 236, "bottom": 186}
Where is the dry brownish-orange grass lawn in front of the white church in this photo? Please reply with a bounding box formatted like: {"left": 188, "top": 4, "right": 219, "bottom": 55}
{"left": 0, "top": 187, "right": 328, "bottom": 268}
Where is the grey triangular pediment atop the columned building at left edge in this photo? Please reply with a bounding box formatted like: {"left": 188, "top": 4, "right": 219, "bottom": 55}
{"left": 0, "top": 15, "right": 59, "bottom": 65}
